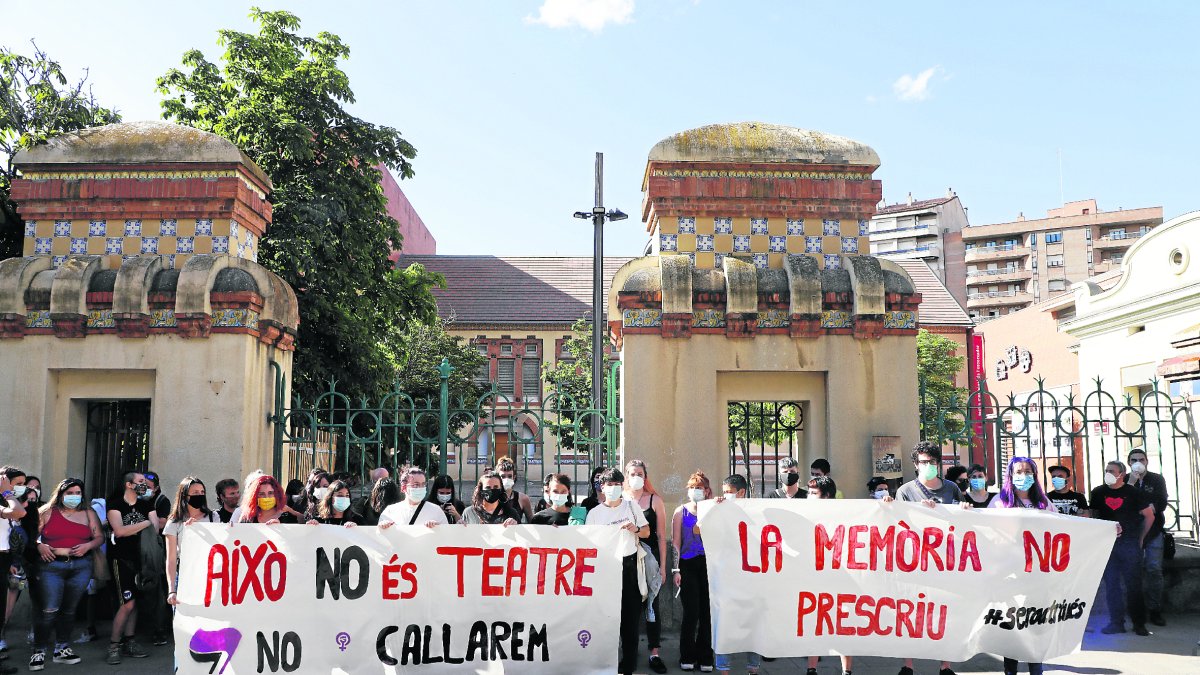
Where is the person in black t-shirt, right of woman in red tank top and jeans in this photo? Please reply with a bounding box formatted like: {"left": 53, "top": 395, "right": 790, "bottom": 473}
{"left": 104, "top": 471, "right": 160, "bottom": 665}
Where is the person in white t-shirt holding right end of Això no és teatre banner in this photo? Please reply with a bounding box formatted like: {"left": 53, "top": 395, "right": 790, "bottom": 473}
{"left": 587, "top": 468, "right": 650, "bottom": 675}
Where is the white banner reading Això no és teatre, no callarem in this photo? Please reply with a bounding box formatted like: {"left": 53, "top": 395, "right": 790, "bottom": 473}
{"left": 174, "top": 524, "right": 628, "bottom": 675}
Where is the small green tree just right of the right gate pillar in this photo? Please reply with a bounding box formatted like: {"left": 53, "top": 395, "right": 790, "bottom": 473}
{"left": 917, "top": 328, "right": 967, "bottom": 440}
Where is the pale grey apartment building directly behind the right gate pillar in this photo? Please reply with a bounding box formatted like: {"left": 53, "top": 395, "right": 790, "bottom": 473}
{"left": 868, "top": 189, "right": 967, "bottom": 306}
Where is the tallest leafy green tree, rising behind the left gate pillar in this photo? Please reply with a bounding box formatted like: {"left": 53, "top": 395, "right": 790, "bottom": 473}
{"left": 157, "top": 8, "right": 444, "bottom": 399}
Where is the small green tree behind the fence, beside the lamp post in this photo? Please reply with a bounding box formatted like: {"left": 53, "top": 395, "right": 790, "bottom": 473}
{"left": 541, "top": 318, "right": 616, "bottom": 448}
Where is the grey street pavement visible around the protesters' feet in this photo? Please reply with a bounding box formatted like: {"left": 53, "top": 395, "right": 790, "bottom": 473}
{"left": 5, "top": 611, "right": 1200, "bottom": 675}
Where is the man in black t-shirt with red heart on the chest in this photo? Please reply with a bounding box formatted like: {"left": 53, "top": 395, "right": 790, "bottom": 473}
{"left": 1090, "top": 461, "right": 1154, "bottom": 635}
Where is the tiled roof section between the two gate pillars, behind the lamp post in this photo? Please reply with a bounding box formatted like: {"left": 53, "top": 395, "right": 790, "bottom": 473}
{"left": 398, "top": 256, "right": 632, "bottom": 325}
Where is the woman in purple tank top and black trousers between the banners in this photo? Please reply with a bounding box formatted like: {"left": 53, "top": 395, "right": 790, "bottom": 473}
{"left": 671, "top": 471, "right": 714, "bottom": 673}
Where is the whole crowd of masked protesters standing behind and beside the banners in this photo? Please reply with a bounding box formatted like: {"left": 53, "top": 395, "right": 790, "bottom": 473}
{"left": 0, "top": 442, "right": 1168, "bottom": 675}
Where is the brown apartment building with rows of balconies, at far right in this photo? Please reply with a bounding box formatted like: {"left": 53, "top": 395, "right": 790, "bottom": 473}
{"left": 962, "top": 199, "right": 1163, "bottom": 323}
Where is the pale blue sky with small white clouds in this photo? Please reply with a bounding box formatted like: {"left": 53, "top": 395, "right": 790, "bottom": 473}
{"left": 0, "top": 0, "right": 1200, "bottom": 255}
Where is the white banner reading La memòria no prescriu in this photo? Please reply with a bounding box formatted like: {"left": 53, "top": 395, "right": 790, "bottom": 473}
{"left": 700, "top": 500, "right": 1116, "bottom": 662}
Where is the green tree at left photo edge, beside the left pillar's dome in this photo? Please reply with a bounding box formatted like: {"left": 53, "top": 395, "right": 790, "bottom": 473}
{"left": 0, "top": 43, "right": 121, "bottom": 259}
